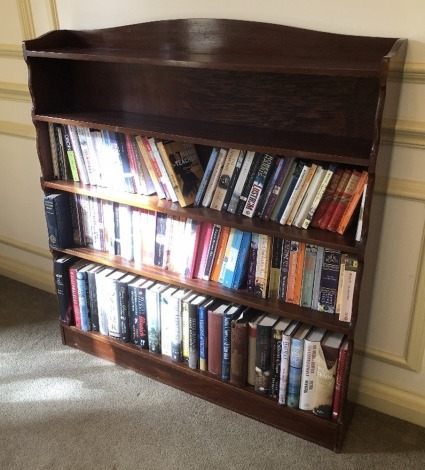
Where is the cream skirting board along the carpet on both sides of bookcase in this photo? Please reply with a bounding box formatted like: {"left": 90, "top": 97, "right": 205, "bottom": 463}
{"left": 0, "top": 256, "right": 425, "bottom": 427}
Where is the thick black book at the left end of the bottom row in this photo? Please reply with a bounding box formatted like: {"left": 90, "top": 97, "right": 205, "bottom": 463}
{"left": 53, "top": 255, "right": 77, "bottom": 326}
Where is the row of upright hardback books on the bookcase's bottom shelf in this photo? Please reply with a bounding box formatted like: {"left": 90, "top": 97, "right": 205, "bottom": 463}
{"left": 54, "top": 256, "right": 347, "bottom": 419}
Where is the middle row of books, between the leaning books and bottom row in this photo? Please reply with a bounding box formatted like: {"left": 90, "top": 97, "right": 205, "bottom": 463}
{"left": 45, "top": 193, "right": 358, "bottom": 322}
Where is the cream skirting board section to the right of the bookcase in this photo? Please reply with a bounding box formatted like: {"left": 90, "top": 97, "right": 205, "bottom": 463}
{"left": 348, "top": 374, "right": 425, "bottom": 427}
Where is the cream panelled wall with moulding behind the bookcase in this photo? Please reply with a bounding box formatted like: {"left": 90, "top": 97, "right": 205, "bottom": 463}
{"left": 0, "top": 0, "right": 425, "bottom": 426}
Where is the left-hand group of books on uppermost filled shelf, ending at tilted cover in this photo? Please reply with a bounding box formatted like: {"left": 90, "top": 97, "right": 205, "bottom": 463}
{"left": 49, "top": 123, "right": 204, "bottom": 207}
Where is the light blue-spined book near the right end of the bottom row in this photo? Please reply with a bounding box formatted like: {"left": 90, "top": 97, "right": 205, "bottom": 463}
{"left": 286, "top": 323, "right": 311, "bottom": 408}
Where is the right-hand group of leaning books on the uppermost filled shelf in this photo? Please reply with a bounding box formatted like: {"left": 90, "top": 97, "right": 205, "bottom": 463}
{"left": 194, "top": 148, "right": 367, "bottom": 234}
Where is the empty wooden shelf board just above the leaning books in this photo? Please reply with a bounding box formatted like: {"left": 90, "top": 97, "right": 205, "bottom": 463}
{"left": 34, "top": 110, "right": 372, "bottom": 168}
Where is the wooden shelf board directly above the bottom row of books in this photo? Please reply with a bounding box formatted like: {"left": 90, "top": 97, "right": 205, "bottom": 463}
{"left": 57, "top": 247, "right": 354, "bottom": 337}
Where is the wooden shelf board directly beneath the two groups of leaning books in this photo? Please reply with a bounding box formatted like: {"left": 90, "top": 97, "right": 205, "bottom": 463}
{"left": 43, "top": 180, "right": 365, "bottom": 255}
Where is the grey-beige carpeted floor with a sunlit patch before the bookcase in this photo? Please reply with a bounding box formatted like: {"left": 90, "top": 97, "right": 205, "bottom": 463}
{"left": 0, "top": 276, "right": 425, "bottom": 470}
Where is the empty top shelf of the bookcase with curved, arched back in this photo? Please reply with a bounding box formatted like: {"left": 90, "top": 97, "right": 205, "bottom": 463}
{"left": 25, "top": 18, "right": 403, "bottom": 79}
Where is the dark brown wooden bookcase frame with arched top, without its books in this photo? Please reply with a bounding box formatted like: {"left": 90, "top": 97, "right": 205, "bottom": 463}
{"left": 23, "top": 19, "right": 407, "bottom": 451}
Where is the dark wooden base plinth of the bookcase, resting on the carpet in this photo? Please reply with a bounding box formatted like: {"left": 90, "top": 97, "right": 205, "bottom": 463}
{"left": 61, "top": 325, "right": 345, "bottom": 452}
